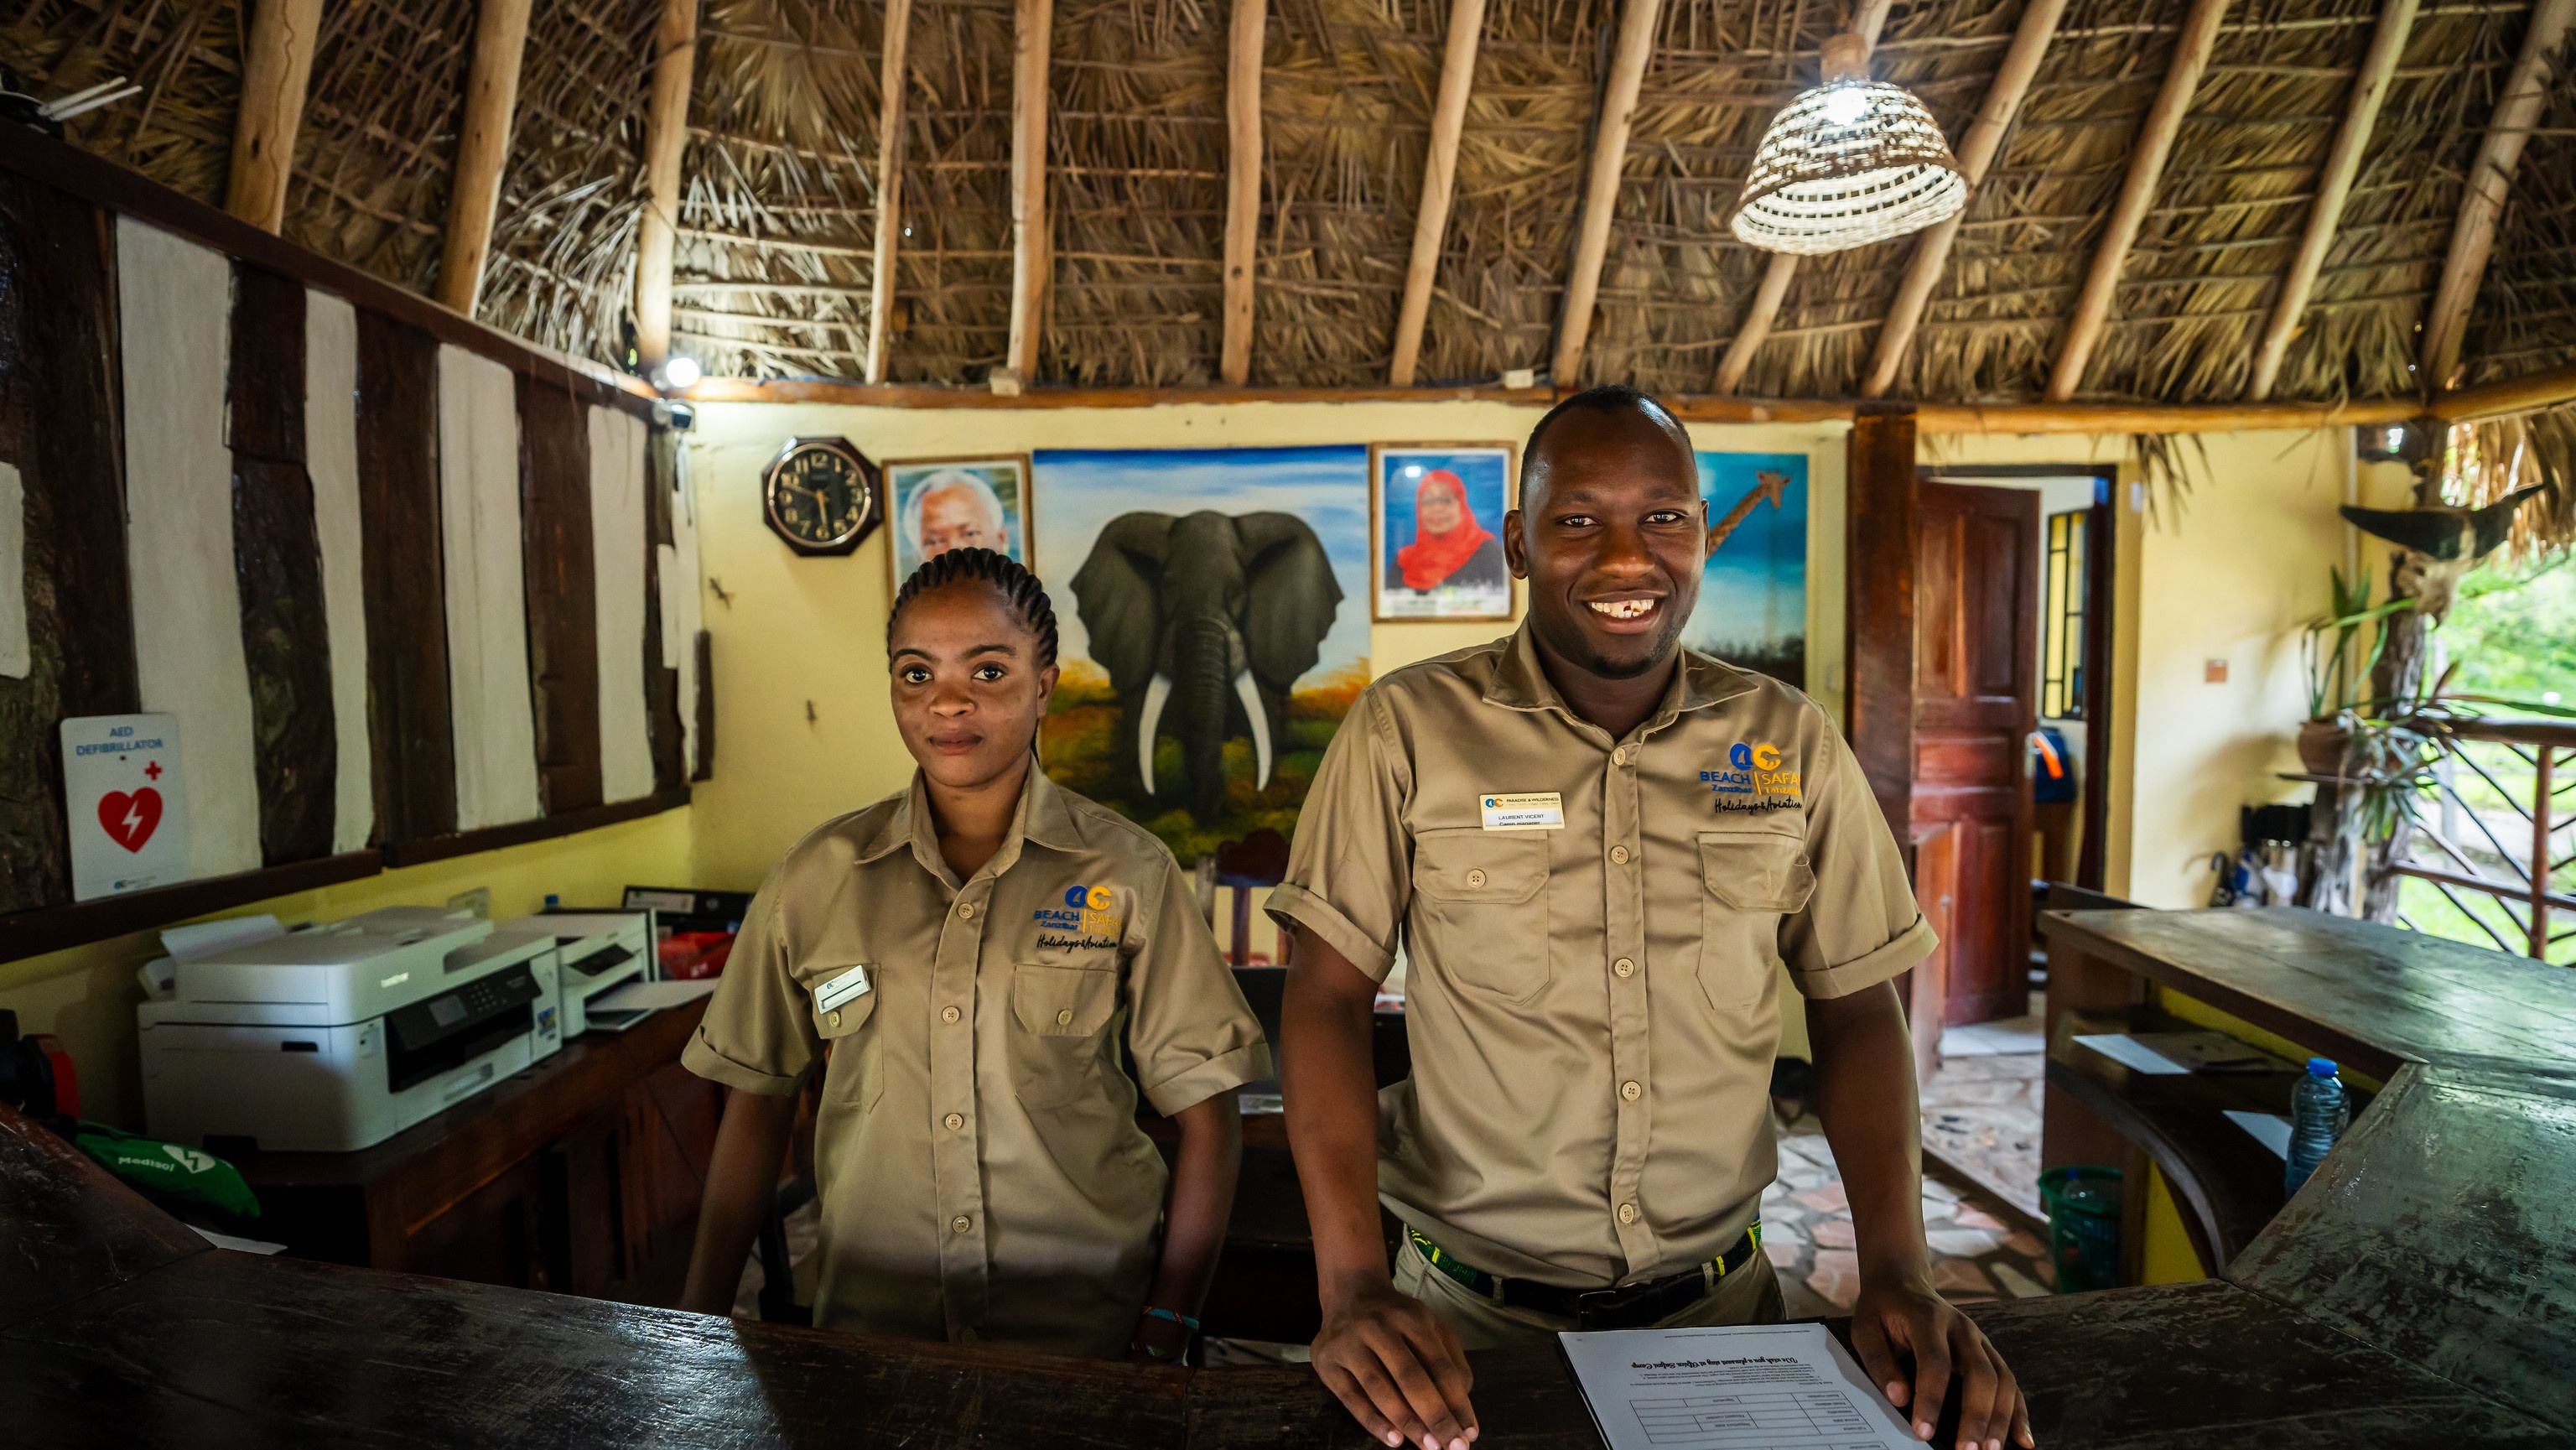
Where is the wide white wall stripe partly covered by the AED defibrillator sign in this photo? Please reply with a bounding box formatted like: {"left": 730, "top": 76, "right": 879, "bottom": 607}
{"left": 116, "top": 216, "right": 260, "bottom": 876}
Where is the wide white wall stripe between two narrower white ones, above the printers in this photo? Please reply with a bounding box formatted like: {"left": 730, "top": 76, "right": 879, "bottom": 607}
{"left": 438, "top": 346, "right": 538, "bottom": 832}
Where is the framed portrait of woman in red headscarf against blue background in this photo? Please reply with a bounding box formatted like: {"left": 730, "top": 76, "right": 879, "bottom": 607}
{"left": 1368, "top": 443, "right": 1517, "bottom": 621}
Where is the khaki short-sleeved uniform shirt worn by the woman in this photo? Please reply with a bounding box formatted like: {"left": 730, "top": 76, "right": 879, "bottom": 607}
{"left": 680, "top": 770, "right": 1270, "bottom": 1357}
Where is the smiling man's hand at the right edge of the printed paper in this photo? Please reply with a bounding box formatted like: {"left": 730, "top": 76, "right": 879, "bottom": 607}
{"left": 1852, "top": 1275, "right": 2033, "bottom": 1450}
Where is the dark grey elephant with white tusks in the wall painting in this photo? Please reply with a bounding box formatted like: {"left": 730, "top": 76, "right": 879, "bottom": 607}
{"left": 1074, "top": 510, "right": 1343, "bottom": 827}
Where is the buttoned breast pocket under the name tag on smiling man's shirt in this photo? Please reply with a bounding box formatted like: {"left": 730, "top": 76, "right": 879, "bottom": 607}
{"left": 1415, "top": 829, "right": 1548, "bottom": 1002}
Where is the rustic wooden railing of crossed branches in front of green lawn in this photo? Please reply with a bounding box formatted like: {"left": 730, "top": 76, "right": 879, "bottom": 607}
{"left": 2388, "top": 719, "right": 2576, "bottom": 961}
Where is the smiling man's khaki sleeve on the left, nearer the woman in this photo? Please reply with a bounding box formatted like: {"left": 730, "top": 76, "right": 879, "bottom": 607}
{"left": 1267, "top": 690, "right": 1415, "bottom": 981}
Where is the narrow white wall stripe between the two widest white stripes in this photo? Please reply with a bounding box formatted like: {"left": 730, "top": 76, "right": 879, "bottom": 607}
{"left": 304, "top": 291, "right": 377, "bottom": 853}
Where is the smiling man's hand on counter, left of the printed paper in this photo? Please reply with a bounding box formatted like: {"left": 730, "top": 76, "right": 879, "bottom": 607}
{"left": 1314, "top": 1277, "right": 1476, "bottom": 1450}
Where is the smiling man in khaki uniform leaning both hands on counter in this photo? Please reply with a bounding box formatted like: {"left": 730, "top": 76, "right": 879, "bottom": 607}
{"left": 1270, "top": 389, "right": 2030, "bottom": 1450}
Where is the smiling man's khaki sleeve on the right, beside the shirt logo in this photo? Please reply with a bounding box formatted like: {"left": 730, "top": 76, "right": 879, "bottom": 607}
{"left": 1780, "top": 719, "right": 1940, "bottom": 996}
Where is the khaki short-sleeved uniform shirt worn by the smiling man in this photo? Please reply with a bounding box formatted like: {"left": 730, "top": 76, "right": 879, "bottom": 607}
{"left": 1270, "top": 626, "right": 1935, "bottom": 1288}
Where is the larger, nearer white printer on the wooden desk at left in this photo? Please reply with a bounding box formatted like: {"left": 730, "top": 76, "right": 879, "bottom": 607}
{"left": 134, "top": 907, "right": 562, "bottom": 1154}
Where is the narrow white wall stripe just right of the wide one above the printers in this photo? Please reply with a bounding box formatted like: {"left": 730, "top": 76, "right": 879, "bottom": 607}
{"left": 589, "top": 407, "right": 652, "bottom": 801}
